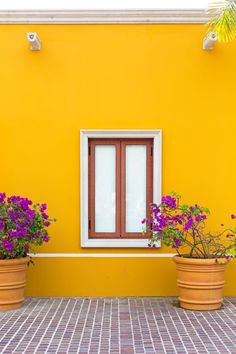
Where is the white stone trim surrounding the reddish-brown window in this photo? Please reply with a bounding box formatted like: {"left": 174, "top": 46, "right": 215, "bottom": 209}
{"left": 80, "top": 129, "right": 162, "bottom": 248}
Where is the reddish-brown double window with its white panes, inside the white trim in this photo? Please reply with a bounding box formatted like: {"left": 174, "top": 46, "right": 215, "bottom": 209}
{"left": 88, "top": 138, "right": 153, "bottom": 239}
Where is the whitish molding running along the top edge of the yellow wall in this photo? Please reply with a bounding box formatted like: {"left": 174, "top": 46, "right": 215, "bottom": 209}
{"left": 0, "top": 10, "right": 209, "bottom": 24}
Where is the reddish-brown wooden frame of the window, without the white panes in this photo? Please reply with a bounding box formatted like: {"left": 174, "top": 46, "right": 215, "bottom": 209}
{"left": 88, "top": 138, "right": 153, "bottom": 239}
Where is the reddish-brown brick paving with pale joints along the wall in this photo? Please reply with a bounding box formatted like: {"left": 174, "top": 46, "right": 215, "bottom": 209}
{"left": 0, "top": 297, "right": 236, "bottom": 354}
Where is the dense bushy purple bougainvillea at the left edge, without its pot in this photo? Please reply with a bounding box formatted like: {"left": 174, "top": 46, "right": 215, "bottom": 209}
{"left": 0, "top": 193, "right": 56, "bottom": 259}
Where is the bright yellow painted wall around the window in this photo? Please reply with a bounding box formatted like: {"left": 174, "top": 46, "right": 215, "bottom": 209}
{"left": 0, "top": 25, "right": 236, "bottom": 296}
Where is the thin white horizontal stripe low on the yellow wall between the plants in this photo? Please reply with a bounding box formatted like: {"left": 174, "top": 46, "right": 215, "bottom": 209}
{"left": 30, "top": 253, "right": 175, "bottom": 258}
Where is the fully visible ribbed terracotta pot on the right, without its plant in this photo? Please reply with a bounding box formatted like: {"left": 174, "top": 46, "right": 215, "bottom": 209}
{"left": 174, "top": 256, "right": 227, "bottom": 311}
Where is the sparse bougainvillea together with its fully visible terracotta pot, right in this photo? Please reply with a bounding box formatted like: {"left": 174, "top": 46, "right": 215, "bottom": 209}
{"left": 142, "top": 193, "right": 236, "bottom": 310}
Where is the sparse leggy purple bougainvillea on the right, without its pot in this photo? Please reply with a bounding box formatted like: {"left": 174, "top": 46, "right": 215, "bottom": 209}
{"left": 142, "top": 193, "right": 236, "bottom": 259}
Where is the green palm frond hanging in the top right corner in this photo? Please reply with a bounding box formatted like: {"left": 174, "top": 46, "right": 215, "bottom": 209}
{"left": 208, "top": 0, "right": 236, "bottom": 42}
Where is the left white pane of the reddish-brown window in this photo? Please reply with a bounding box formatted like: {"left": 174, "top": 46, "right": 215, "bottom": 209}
{"left": 95, "top": 145, "right": 116, "bottom": 232}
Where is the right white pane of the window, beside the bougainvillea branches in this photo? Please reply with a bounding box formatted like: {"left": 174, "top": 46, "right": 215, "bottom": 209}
{"left": 125, "top": 145, "right": 147, "bottom": 232}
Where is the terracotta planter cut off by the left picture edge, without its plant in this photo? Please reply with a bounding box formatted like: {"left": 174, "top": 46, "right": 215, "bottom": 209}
{"left": 0, "top": 257, "right": 30, "bottom": 311}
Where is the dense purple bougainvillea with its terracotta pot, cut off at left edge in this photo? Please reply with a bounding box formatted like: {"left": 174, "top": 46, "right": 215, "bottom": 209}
{"left": 0, "top": 193, "right": 55, "bottom": 310}
